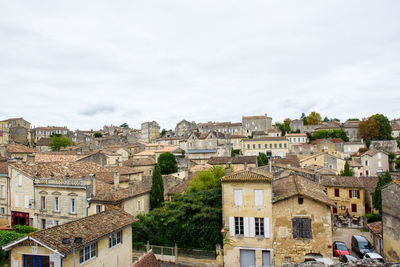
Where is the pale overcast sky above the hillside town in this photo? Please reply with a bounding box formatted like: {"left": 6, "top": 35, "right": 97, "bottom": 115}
{"left": 0, "top": 0, "right": 400, "bottom": 130}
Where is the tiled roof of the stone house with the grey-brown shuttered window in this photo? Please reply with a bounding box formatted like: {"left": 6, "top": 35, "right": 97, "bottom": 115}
{"left": 273, "top": 175, "right": 335, "bottom": 206}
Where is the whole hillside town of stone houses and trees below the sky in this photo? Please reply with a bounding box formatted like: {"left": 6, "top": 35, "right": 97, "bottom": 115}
{"left": 0, "top": 111, "right": 400, "bottom": 267}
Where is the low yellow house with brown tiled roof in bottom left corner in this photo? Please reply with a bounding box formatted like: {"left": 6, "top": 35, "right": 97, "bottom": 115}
{"left": 3, "top": 209, "right": 136, "bottom": 267}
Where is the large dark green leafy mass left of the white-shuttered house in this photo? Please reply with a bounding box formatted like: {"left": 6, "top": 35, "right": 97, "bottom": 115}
{"left": 132, "top": 187, "right": 222, "bottom": 250}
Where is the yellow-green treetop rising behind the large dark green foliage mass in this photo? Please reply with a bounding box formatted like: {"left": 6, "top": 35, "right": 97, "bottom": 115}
{"left": 188, "top": 166, "right": 225, "bottom": 191}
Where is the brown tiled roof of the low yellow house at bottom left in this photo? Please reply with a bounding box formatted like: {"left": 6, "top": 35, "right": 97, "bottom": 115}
{"left": 6, "top": 209, "right": 137, "bottom": 256}
